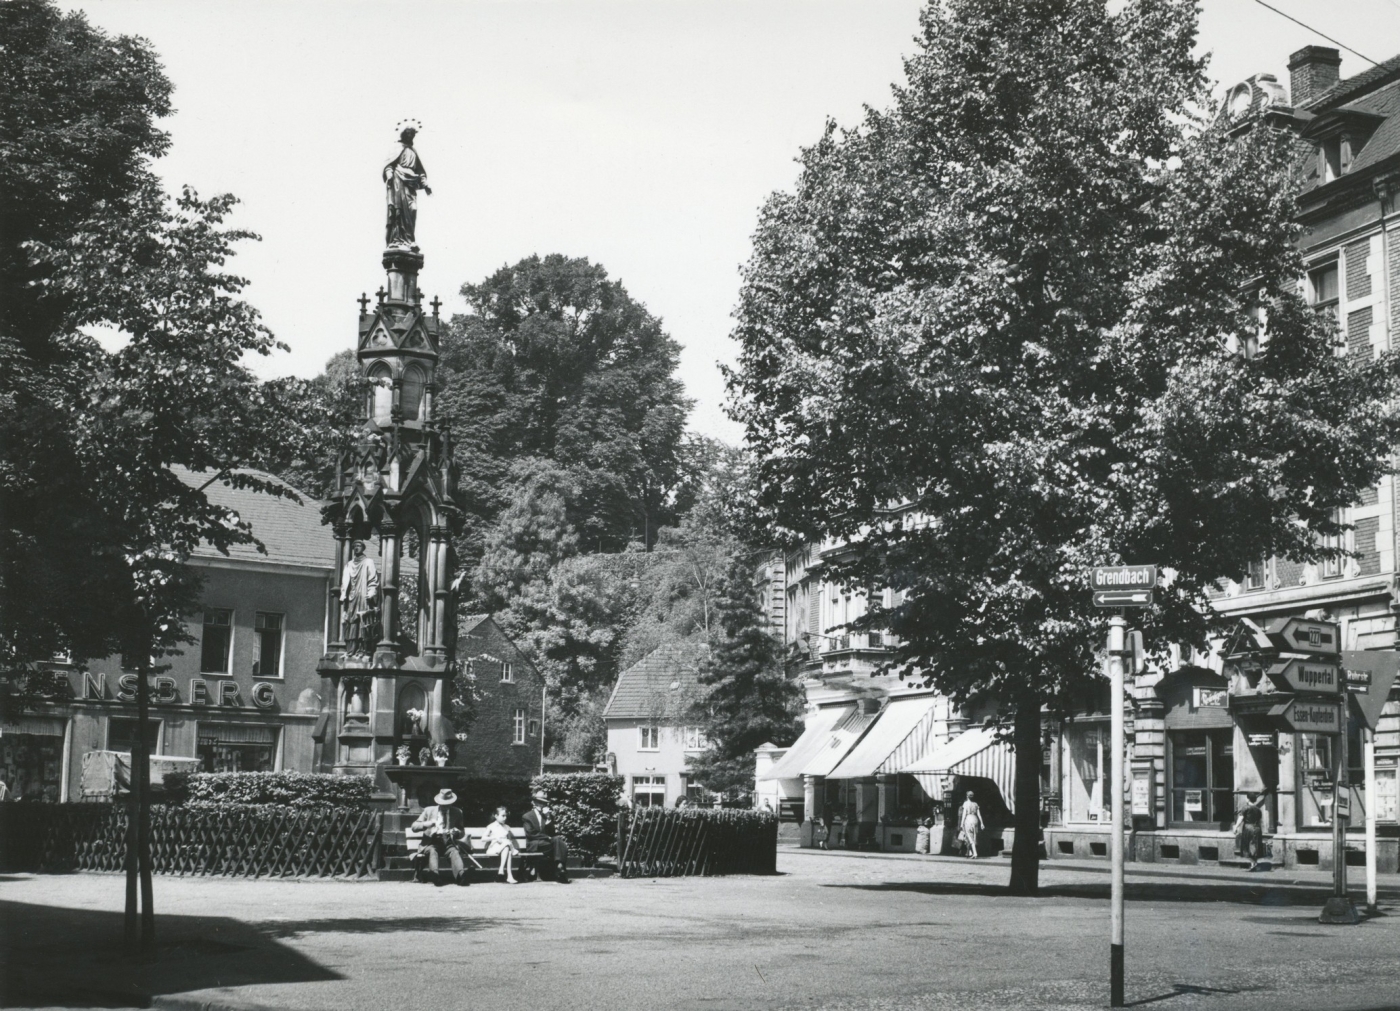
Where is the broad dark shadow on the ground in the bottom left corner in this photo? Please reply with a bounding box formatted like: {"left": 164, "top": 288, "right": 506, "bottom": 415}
{"left": 0, "top": 902, "right": 344, "bottom": 1007}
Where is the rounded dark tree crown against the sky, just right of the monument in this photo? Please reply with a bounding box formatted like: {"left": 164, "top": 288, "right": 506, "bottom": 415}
{"left": 437, "top": 253, "right": 690, "bottom": 562}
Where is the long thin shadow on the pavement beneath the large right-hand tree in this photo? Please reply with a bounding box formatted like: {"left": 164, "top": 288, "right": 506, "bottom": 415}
{"left": 822, "top": 878, "right": 1400, "bottom": 909}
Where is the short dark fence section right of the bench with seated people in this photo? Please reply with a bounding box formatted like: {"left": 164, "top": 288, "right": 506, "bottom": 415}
{"left": 617, "top": 808, "right": 778, "bottom": 878}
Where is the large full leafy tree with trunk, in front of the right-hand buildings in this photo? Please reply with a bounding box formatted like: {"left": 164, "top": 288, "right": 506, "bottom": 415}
{"left": 729, "top": 0, "right": 1396, "bottom": 891}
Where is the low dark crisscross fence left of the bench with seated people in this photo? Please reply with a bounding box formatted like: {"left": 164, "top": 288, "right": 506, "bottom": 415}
{"left": 0, "top": 802, "right": 382, "bottom": 878}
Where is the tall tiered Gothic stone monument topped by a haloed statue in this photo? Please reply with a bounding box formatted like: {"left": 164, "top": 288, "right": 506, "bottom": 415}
{"left": 318, "top": 123, "right": 461, "bottom": 791}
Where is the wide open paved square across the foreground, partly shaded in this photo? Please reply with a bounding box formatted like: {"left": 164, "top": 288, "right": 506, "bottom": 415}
{"left": 0, "top": 850, "right": 1400, "bottom": 1011}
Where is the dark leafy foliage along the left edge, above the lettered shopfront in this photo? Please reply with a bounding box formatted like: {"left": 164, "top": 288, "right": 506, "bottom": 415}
{"left": 0, "top": 0, "right": 322, "bottom": 667}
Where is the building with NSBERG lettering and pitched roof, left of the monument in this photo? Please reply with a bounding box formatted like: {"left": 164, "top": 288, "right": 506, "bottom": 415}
{"left": 0, "top": 475, "right": 333, "bottom": 801}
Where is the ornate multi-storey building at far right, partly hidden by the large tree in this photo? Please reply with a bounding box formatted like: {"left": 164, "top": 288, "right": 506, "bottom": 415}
{"left": 1046, "top": 46, "right": 1400, "bottom": 871}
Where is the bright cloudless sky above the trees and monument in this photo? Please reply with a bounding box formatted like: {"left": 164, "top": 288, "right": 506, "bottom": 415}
{"left": 67, "top": 0, "right": 1400, "bottom": 441}
